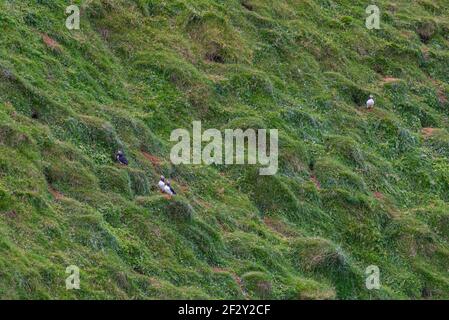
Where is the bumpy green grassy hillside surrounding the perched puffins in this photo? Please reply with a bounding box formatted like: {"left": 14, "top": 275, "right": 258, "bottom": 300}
{"left": 0, "top": 0, "right": 449, "bottom": 299}
